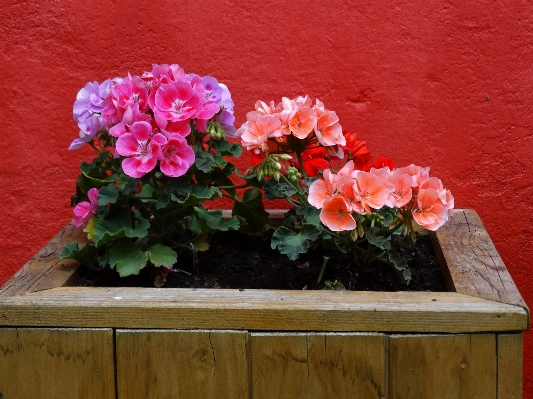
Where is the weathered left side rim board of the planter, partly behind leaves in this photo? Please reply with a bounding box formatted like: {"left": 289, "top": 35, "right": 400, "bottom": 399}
{"left": 0, "top": 222, "right": 87, "bottom": 298}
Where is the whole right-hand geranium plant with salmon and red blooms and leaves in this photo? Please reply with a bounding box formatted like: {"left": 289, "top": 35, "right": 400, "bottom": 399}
{"left": 237, "top": 96, "right": 454, "bottom": 283}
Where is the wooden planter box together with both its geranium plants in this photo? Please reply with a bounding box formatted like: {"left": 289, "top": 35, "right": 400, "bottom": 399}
{"left": 0, "top": 71, "right": 529, "bottom": 399}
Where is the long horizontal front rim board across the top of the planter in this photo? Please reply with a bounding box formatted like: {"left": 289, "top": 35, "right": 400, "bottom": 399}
{"left": 0, "top": 287, "right": 527, "bottom": 332}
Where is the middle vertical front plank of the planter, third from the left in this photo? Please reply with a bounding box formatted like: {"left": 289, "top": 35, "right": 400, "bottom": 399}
{"left": 250, "top": 333, "right": 385, "bottom": 399}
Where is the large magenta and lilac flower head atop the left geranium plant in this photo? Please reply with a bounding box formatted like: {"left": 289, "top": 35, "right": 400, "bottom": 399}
{"left": 70, "top": 64, "right": 235, "bottom": 178}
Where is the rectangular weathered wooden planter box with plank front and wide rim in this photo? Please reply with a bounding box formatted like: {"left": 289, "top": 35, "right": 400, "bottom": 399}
{"left": 0, "top": 210, "right": 529, "bottom": 399}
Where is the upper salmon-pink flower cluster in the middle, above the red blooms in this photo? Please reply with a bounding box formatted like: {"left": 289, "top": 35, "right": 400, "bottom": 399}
{"left": 237, "top": 96, "right": 346, "bottom": 157}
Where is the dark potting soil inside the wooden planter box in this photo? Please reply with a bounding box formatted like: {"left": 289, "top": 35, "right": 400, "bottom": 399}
{"left": 71, "top": 232, "right": 446, "bottom": 291}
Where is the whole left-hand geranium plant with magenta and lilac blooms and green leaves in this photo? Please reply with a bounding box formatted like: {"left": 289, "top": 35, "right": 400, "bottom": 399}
{"left": 60, "top": 65, "right": 266, "bottom": 282}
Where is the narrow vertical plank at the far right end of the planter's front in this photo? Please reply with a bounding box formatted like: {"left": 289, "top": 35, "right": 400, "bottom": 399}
{"left": 498, "top": 333, "right": 523, "bottom": 399}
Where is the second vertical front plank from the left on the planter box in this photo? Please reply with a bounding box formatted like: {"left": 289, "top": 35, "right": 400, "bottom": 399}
{"left": 116, "top": 330, "right": 249, "bottom": 399}
